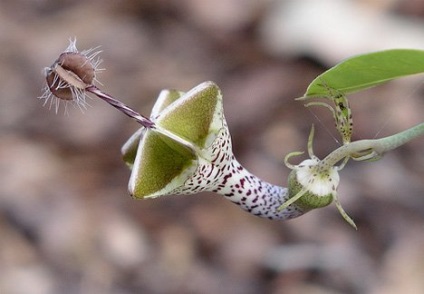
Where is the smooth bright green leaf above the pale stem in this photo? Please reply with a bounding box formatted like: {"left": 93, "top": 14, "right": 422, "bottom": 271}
{"left": 302, "top": 49, "right": 424, "bottom": 99}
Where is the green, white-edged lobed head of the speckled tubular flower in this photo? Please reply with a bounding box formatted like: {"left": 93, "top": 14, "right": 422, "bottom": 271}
{"left": 123, "top": 82, "right": 225, "bottom": 198}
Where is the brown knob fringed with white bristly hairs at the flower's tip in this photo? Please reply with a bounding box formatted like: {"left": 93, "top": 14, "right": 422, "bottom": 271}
{"left": 38, "top": 39, "right": 103, "bottom": 113}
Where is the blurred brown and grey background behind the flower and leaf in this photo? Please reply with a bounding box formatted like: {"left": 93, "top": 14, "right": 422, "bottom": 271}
{"left": 0, "top": 0, "right": 424, "bottom": 294}
